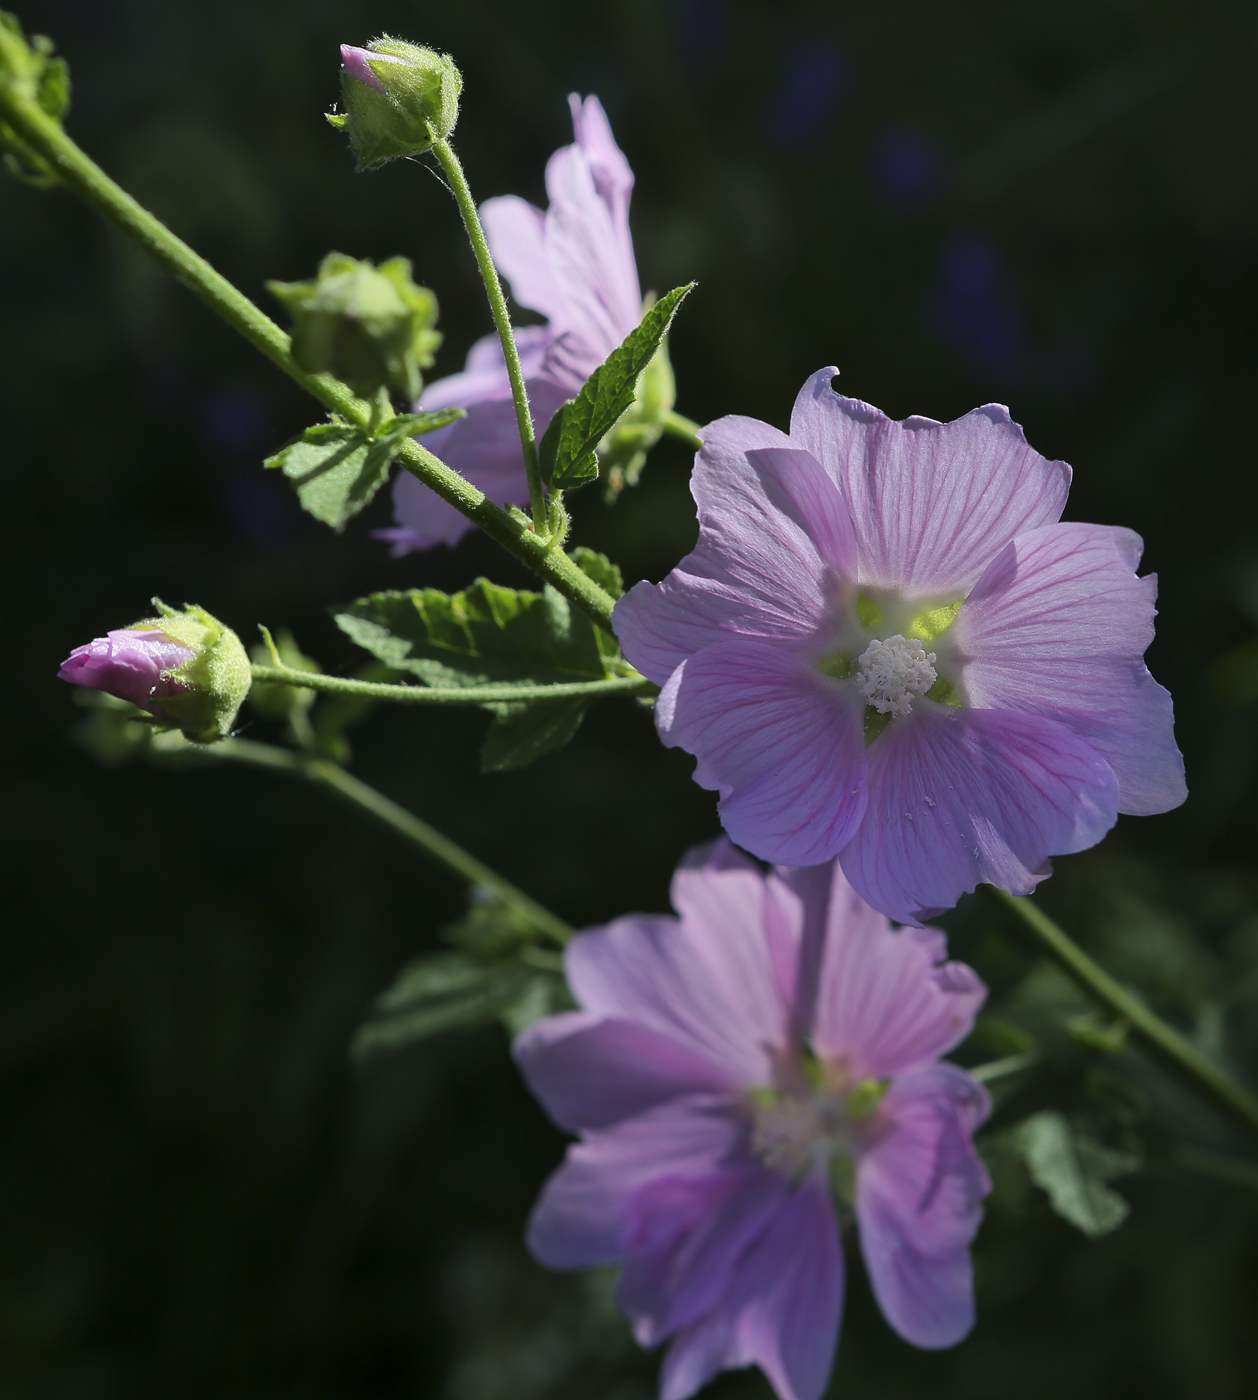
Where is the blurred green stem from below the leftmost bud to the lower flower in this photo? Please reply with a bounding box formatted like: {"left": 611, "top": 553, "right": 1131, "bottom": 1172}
{"left": 213, "top": 739, "right": 572, "bottom": 944}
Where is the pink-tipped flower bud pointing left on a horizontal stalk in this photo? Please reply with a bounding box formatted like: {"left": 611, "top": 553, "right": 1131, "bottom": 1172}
{"left": 57, "top": 598, "right": 252, "bottom": 743}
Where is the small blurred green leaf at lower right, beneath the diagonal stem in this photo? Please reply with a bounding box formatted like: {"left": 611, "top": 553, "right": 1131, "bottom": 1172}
{"left": 1012, "top": 1109, "right": 1140, "bottom": 1238}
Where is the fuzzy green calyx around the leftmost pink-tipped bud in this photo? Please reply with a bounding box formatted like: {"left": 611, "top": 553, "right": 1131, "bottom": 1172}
{"left": 139, "top": 598, "right": 252, "bottom": 743}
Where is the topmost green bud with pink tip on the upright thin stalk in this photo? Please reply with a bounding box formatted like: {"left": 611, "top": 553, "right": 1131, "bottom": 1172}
{"left": 327, "top": 34, "right": 463, "bottom": 169}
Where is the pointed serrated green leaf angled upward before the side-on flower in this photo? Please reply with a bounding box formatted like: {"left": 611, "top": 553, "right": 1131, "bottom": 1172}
{"left": 539, "top": 283, "right": 694, "bottom": 489}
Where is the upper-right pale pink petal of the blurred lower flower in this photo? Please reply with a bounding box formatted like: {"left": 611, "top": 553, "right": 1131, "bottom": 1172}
{"left": 812, "top": 869, "right": 987, "bottom": 1079}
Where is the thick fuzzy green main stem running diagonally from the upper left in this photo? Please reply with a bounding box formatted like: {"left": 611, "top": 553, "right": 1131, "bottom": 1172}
{"left": 0, "top": 83, "right": 614, "bottom": 631}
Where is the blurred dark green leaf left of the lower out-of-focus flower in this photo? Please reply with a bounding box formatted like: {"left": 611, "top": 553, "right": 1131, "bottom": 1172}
{"left": 350, "top": 952, "right": 539, "bottom": 1060}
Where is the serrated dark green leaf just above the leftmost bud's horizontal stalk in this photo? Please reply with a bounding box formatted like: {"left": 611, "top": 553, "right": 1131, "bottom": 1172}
{"left": 336, "top": 578, "right": 607, "bottom": 686}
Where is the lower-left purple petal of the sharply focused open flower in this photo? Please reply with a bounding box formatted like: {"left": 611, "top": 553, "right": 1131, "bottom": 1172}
{"left": 656, "top": 638, "right": 868, "bottom": 865}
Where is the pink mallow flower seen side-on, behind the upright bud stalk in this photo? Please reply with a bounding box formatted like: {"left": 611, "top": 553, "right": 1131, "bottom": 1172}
{"left": 379, "top": 94, "right": 642, "bottom": 554}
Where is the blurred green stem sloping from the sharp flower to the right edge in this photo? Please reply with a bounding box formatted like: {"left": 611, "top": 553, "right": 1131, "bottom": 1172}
{"left": 982, "top": 885, "right": 1258, "bottom": 1133}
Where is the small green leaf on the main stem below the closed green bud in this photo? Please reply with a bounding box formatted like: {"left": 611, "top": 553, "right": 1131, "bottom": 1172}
{"left": 263, "top": 409, "right": 463, "bottom": 531}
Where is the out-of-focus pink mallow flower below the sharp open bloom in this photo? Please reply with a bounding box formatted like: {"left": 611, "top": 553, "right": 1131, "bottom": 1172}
{"left": 515, "top": 840, "right": 989, "bottom": 1400}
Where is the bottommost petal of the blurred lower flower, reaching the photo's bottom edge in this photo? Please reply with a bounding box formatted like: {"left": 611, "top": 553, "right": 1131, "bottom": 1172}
{"left": 660, "top": 1176, "right": 842, "bottom": 1400}
